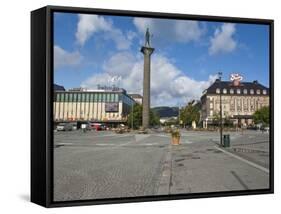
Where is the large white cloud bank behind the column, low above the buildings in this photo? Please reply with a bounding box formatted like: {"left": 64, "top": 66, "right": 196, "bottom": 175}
{"left": 81, "top": 52, "right": 216, "bottom": 106}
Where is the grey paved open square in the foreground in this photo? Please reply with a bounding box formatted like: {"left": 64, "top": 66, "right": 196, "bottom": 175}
{"left": 54, "top": 130, "right": 269, "bottom": 201}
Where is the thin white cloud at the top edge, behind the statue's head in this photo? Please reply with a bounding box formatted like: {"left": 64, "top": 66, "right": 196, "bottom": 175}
{"left": 133, "top": 18, "right": 202, "bottom": 43}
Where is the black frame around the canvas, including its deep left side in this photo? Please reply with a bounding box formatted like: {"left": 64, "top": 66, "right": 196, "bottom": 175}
{"left": 31, "top": 6, "right": 274, "bottom": 207}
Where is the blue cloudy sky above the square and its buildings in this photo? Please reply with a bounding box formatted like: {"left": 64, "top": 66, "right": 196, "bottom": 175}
{"left": 54, "top": 13, "right": 269, "bottom": 106}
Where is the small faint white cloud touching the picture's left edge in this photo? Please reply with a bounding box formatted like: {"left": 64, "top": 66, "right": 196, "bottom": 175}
{"left": 54, "top": 45, "right": 82, "bottom": 68}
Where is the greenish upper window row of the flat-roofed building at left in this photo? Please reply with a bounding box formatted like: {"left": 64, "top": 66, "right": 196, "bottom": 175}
{"left": 54, "top": 93, "right": 119, "bottom": 102}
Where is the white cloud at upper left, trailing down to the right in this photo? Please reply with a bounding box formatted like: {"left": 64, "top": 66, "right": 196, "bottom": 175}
{"left": 75, "top": 14, "right": 131, "bottom": 50}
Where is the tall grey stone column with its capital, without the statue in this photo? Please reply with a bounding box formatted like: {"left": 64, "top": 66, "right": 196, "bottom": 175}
{"left": 141, "top": 46, "right": 154, "bottom": 129}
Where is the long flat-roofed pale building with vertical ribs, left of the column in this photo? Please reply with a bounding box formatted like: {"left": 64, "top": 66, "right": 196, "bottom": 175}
{"left": 53, "top": 87, "right": 135, "bottom": 124}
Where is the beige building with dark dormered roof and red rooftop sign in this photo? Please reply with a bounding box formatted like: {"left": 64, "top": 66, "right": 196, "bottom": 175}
{"left": 201, "top": 79, "right": 270, "bottom": 128}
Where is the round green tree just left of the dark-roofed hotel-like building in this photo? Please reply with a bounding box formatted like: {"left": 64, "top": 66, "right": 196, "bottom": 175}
{"left": 180, "top": 102, "right": 200, "bottom": 125}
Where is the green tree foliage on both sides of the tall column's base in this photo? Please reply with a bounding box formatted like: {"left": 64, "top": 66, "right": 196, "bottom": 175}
{"left": 127, "top": 103, "right": 160, "bottom": 129}
